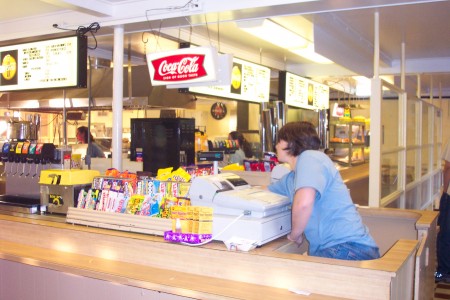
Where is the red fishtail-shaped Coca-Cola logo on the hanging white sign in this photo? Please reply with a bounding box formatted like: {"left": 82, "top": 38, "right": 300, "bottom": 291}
{"left": 151, "top": 54, "right": 207, "bottom": 82}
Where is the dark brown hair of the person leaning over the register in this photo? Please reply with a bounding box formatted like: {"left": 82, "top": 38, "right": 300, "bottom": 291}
{"left": 277, "top": 122, "right": 320, "bottom": 156}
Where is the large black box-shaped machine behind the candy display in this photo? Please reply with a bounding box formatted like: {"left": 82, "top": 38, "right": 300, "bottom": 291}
{"left": 130, "top": 118, "right": 195, "bottom": 175}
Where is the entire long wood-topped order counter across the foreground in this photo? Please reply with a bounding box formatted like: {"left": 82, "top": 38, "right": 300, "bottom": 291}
{"left": 0, "top": 208, "right": 437, "bottom": 300}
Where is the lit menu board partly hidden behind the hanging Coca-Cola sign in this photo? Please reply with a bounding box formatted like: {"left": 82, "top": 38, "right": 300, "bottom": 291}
{"left": 189, "top": 58, "right": 270, "bottom": 103}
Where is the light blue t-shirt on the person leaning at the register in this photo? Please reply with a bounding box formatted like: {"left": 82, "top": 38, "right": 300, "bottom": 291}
{"left": 269, "top": 150, "right": 377, "bottom": 255}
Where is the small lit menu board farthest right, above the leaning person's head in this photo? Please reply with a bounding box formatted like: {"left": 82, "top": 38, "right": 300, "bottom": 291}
{"left": 278, "top": 71, "right": 330, "bottom": 110}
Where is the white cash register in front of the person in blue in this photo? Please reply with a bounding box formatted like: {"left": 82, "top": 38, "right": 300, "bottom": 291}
{"left": 189, "top": 173, "right": 291, "bottom": 246}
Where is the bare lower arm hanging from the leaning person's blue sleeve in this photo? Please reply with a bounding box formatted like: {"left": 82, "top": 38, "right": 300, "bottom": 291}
{"left": 288, "top": 188, "right": 316, "bottom": 246}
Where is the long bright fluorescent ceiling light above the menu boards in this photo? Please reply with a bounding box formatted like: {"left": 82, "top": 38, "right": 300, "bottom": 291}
{"left": 237, "top": 19, "right": 333, "bottom": 64}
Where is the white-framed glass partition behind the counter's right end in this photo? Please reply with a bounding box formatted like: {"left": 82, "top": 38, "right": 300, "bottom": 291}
{"left": 369, "top": 78, "right": 442, "bottom": 209}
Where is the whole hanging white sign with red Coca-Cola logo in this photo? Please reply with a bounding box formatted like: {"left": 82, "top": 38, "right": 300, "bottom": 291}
{"left": 147, "top": 47, "right": 218, "bottom": 85}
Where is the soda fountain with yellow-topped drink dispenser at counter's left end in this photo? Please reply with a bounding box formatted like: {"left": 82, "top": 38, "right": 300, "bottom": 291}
{"left": 0, "top": 115, "right": 98, "bottom": 214}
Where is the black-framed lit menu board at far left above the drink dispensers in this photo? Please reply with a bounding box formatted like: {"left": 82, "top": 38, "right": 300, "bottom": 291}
{"left": 0, "top": 36, "right": 87, "bottom": 92}
